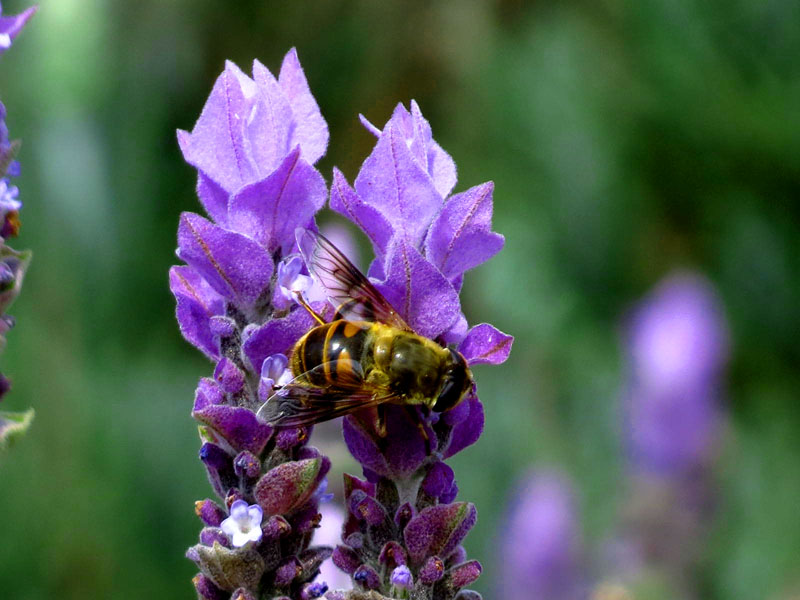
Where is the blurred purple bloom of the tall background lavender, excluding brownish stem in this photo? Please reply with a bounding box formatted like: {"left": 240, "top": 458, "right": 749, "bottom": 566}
{"left": 626, "top": 273, "right": 728, "bottom": 472}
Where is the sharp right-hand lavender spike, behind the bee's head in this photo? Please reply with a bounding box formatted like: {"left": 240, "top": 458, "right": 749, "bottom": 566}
{"left": 328, "top": 102, "right": 512, "bottom": 600}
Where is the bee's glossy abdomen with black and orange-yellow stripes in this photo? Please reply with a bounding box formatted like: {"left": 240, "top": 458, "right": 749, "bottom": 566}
{"left": 291, "top": 320, "right": 374, "bottom": 387}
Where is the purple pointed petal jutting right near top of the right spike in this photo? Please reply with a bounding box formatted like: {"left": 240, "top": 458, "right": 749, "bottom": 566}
{"left": 425, "top": 182, "right": 504, "bottom": 279}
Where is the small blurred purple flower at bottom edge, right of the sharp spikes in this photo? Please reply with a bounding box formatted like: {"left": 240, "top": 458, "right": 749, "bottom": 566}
{"left": 497, "top": 472, "right": 584, "bottom": 600}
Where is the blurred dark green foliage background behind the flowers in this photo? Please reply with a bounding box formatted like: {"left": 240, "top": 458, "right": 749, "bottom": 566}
{"left": 0, "top": 0, "right": 800, "bottom": 600}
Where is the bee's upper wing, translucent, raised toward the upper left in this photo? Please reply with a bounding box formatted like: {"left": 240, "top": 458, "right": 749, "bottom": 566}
{"left": 297, "top": 229, "right": 413, "bottom": 331}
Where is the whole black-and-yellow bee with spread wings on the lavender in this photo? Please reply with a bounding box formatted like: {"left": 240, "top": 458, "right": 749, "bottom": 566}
{"left": 258, "top": 230, "right": 473, "bottom": 437}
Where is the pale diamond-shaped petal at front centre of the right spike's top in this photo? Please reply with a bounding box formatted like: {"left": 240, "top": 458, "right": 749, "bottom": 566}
{"left": 355, "top": 116, "right": 442, "bottom": 247}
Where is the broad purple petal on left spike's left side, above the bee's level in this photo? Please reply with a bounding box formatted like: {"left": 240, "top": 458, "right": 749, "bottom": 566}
{"left": 178, "top": 213, "right": 273, "bottom": 307}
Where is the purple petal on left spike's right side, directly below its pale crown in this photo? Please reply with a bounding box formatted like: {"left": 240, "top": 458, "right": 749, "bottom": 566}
{"left": 228, "top": 147, "right": 327, "bottom": 256}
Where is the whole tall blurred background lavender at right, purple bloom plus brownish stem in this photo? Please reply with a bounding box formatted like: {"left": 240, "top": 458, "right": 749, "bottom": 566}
{"left": 612, "top": 273, "right": 728, "bottom": 598}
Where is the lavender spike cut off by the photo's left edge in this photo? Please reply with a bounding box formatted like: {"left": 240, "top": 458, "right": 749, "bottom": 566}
{"left": 0, "top": 1, "right": 36, "bottom": 450}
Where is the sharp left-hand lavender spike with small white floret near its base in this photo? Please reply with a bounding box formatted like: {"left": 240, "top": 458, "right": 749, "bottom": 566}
{"left": 170, "top": 50, "right": 331, "bottom": 600}
